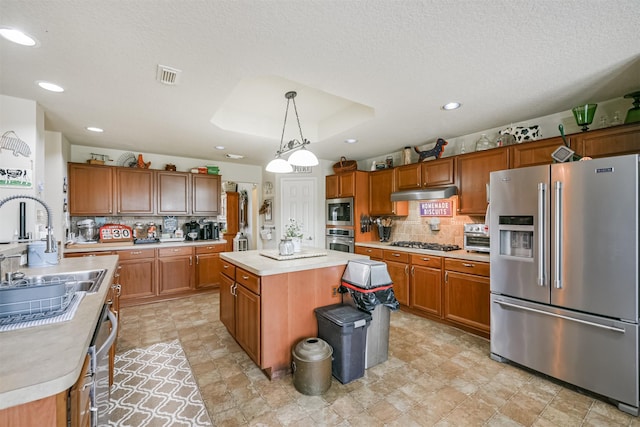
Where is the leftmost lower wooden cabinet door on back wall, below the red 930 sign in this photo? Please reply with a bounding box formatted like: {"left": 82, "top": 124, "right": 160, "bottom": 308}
{"left": 119, "top": 258, "right": 156, "bottom": 302}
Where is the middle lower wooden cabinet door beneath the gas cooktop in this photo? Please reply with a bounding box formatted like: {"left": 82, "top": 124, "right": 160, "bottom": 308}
{"left": 411, "top": 265, "right": 442, "bottom": 317}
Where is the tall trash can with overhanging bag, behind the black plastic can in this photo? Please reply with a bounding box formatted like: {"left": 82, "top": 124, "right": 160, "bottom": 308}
{"left": 342, "top": 260, "right": 399, "bottom": 369}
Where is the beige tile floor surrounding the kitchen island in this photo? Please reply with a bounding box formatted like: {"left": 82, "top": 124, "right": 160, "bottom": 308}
{"left": 118, "top": 293, "right": 640, "bottom": 427}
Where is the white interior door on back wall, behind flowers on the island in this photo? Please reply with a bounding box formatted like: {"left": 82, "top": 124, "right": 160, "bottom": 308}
{"left": 280, "top": 177, "right": 319, "bottom": 246}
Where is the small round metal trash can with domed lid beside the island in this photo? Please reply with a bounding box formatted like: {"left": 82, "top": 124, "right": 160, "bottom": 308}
{"left": 291, "top": 338, "right": 333, "bottom": 396}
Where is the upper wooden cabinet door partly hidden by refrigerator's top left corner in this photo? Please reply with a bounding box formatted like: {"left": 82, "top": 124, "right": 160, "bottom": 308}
{"left": 457, "top": 147, "right": 509, "bottom": 215}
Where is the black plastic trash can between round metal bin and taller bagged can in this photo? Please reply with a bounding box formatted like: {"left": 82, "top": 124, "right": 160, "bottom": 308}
{"left": 315, "top": 304, "right": 371, "bottom": 384}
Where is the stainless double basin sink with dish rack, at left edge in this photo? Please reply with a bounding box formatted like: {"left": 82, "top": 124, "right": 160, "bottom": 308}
{"left": 0, "top": 269, "right": 107, "bottom": 323}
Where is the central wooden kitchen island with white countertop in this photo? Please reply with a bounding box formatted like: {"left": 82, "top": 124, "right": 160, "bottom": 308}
{"left": 220, "top": 249, "right": 369, "bottom": 378}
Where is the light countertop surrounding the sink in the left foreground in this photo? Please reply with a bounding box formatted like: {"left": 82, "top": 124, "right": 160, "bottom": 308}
{"left": 0, "top": 255, "right": 118, "bottom": 409}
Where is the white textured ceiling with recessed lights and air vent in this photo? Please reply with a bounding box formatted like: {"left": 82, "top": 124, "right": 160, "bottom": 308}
{"left": 0, "top": 0, "right": 640, "bottom": 164}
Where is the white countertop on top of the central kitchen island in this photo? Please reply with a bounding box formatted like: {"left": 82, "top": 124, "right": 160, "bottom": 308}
{"left": 220, "top": 248, "right": 369, "bottom": 276}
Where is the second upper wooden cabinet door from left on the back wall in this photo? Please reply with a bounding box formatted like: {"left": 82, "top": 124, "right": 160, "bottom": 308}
{"left": 115, "top": 168, "right": 154, "bottom": 215}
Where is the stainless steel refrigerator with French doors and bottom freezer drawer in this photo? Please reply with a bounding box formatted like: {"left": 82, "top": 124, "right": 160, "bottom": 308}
{"left": 490, "top": 155, "right": 640, "bottom": 416}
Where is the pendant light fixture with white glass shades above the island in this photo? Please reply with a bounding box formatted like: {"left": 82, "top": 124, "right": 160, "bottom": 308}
{"left": 266, "top": 91, "right": 318, "bottom": 173}
